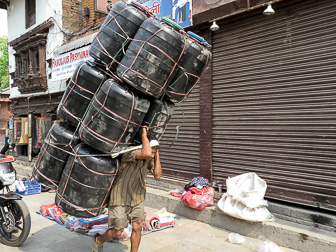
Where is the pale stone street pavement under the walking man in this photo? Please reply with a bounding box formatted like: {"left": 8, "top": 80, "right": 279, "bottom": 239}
{"left": 0, "top": 192, "right": 297, "bottom": 252}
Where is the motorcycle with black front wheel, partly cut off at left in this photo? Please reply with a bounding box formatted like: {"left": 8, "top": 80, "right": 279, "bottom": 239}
{"left": 0, "top": 154, "right": 31, "bottom": 247}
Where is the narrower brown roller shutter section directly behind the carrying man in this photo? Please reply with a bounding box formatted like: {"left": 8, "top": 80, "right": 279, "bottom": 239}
{"left": 160, "top": 84, "right": 200, "bottom": 182}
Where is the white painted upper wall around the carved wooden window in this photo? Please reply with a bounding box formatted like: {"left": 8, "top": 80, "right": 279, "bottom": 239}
{"left": 7, "top": 0, "right": 65, "bottom": 99}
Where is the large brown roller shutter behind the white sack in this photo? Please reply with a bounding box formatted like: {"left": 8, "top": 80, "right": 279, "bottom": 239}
{"left": 213, "top": 0, "right": 336, "bottom": 211}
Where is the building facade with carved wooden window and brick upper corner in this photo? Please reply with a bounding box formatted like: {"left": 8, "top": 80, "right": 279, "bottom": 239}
{"left": 0, "top": 0, "right": 107, "bottom": 161}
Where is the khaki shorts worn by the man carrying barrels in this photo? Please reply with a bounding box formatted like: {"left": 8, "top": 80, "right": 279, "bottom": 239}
{"left": 108, "top": 202, "right": 145, "bottom": 229}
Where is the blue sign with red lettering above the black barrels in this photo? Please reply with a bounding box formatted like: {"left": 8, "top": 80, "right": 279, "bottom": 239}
{"left": 136, "top": 0, "right": 192, "bottom": 27}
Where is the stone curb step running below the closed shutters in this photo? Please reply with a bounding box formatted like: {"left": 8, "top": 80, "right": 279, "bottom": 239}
{"left": 145, "top": 187, "right": 336, "bottom": 252}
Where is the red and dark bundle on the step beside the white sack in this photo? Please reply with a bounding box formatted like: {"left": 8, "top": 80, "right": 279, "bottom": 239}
{"left": 181, "top": 177, "right": 215, "bottom": 210}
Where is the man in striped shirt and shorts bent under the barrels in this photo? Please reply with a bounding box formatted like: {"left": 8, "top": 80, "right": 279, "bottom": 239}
{"left": 92, "top": 127, "right": 161, "bottom": 252}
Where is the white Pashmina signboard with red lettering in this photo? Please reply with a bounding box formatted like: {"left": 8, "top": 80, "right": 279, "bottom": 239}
{"left": 52, "top": 45, "right": 93, "bottom": 81}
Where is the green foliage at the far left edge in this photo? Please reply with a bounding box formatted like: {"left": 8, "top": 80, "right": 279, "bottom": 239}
{"left": 0, "top": 38, "right": 9, "bottom": 90}
